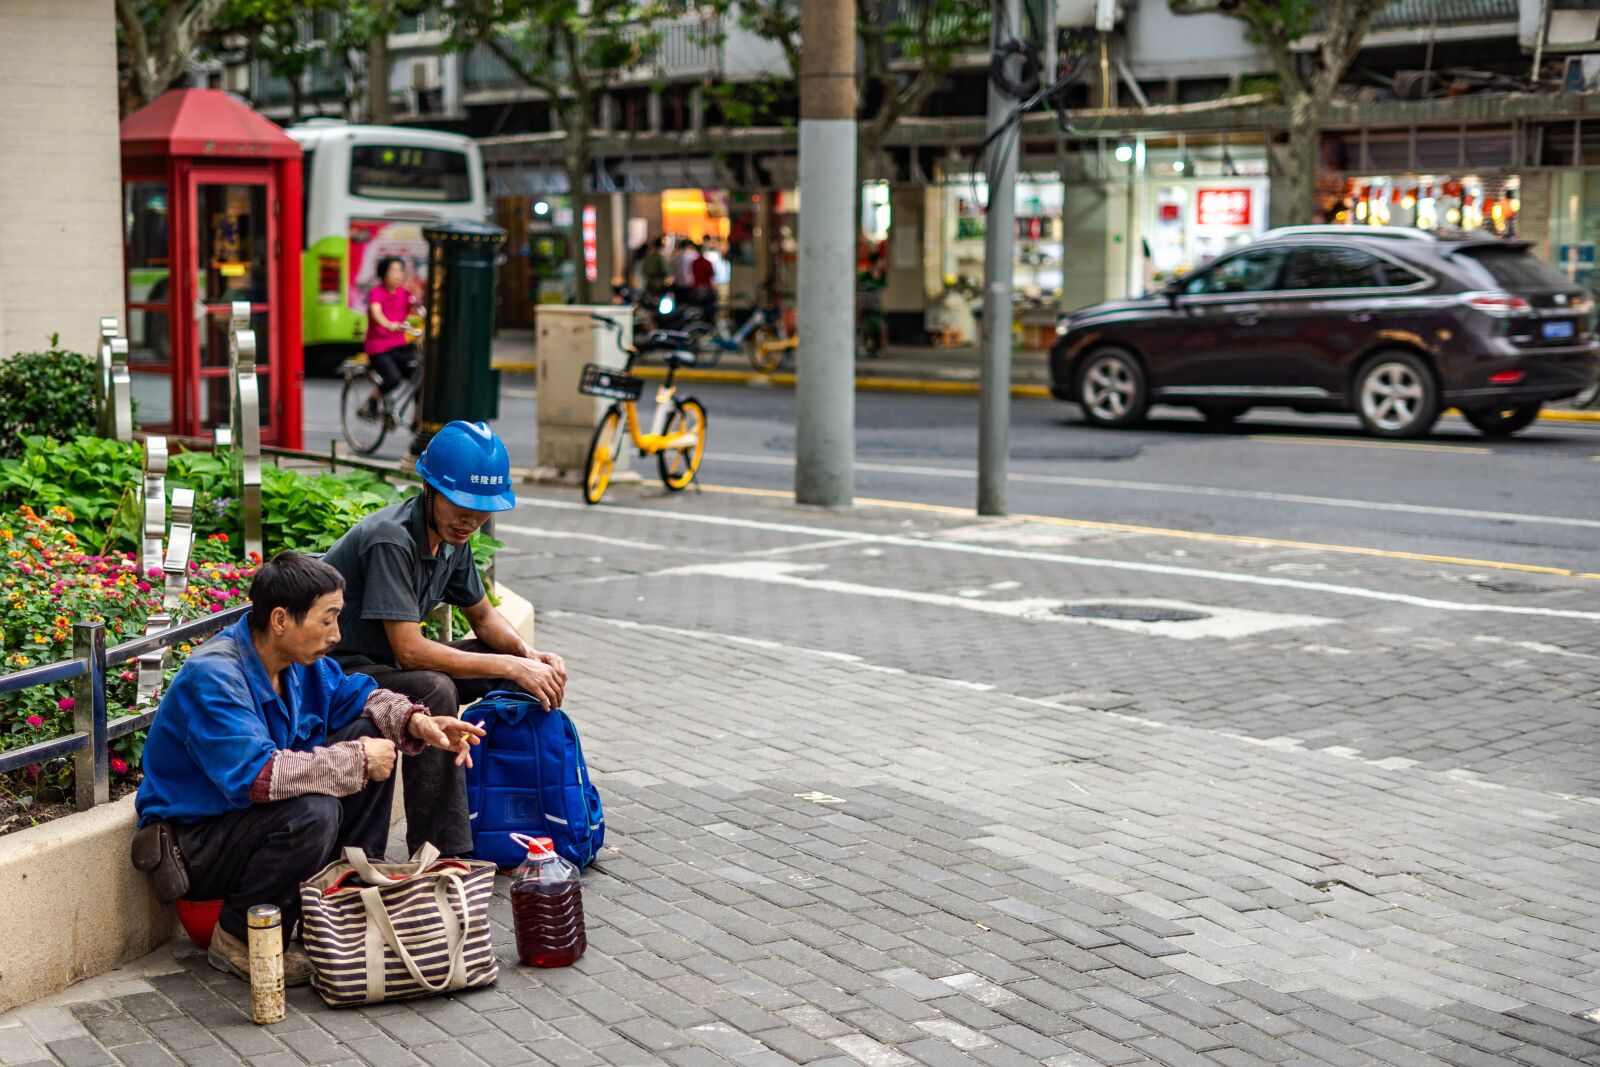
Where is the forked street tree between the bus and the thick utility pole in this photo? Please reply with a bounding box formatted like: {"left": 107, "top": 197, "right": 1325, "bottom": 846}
{"left": 448, "top": 0, "right": 674, "bottom": 304}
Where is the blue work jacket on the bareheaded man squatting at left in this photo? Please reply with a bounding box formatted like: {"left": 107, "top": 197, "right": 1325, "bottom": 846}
{"left": 134, "top": 614, "right": 378, "bottom": 825}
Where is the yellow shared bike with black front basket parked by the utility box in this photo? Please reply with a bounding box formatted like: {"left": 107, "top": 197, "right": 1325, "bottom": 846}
{"left": 578, "top": 315, "right": 706, "bottom": 504}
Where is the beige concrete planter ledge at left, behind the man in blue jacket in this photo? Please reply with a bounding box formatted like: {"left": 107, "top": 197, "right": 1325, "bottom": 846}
{"left": 0, "top": 797, "right": 176, "bottom": 1011}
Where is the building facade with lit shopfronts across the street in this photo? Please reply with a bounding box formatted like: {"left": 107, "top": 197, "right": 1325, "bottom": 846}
{"left": 233, "top": 0, "right": 1600, "bottom": 339}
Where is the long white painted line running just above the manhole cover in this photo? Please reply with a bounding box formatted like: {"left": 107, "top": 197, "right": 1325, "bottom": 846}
{"left": 498, "top": 496, "right": 1600, "bottom": 622}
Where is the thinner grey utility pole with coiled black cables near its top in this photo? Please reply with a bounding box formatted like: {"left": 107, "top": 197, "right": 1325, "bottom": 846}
{"left": 972, "top": 0, "right": 1022, "bottom": 515}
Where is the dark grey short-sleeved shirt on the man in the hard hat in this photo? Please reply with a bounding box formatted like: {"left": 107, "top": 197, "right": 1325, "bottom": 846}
{"left": 323, "top": 493, "right": 483, "bottom": 670}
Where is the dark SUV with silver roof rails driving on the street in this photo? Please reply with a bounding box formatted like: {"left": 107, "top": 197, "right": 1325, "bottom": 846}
{"left": 1050, "top": 226, "right": 1600, "bottom": 437}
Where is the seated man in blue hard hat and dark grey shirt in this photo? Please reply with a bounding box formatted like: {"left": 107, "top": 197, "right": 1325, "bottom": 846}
{"left": 323, "top": 421, "right": 566, "bottom": 856}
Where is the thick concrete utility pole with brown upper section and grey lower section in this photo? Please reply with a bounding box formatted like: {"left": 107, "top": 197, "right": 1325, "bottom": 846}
{"left": 795, "top": 0, "right": 861, "bottom": 507}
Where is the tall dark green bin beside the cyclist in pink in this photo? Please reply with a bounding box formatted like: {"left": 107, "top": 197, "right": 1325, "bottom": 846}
{"left": 411, "top": 221, "right": 506, "bottom": 454}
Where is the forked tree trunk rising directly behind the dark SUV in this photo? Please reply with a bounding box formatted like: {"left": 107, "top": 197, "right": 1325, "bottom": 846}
{"left": 1168, "top": 0, "right": 1392, "bottom": 222}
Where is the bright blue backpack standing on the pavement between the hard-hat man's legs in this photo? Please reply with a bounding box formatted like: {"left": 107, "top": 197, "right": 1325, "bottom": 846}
{"left": 461, "top": 691, "right": 605, "bottom": 867}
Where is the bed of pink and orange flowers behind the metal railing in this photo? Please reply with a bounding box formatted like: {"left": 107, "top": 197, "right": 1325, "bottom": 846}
{"left": 0, "top": 506, "right": 256, "bottom": 833}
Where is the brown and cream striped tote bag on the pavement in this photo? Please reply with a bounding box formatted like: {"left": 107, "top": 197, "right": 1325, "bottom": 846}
{"left": 301, "top": 845, "right": 499, "bottom": 1008}
